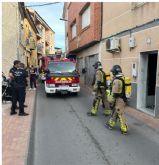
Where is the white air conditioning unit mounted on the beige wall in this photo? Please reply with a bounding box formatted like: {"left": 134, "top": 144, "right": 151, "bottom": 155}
{"left": 106, "top": 37, "right": 121, "bottom": 52}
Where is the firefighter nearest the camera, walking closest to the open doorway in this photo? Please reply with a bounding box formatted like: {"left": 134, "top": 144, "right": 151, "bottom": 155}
{"left": 106, "top": 65, "right": 128, "bottom": 134}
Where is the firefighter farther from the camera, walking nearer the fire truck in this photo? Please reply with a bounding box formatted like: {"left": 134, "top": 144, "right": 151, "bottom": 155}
{"left": 87, "top": 61, "right": 111, "bottom": 116}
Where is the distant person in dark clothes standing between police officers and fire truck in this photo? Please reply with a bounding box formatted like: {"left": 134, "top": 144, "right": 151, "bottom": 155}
{"left": 29, "top": 65, "right": 37, "bottom": 90}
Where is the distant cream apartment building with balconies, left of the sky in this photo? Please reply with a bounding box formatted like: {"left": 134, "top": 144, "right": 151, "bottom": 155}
{"left": 28, "top": 8, "right": 55, "bottom": 62}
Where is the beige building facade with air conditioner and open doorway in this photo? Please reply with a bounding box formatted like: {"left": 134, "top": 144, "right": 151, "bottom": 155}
{"left": 100, "top": 2, "right": 159, "bottom": 117}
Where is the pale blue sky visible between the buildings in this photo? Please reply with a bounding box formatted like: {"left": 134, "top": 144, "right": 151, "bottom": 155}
{"left": 25, "top": 2, "right": 65, "bottom": 50}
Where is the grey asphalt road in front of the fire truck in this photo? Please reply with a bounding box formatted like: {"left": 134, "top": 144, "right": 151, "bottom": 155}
{"left": 30, "top": 86, "right": 159, "bottom": 165}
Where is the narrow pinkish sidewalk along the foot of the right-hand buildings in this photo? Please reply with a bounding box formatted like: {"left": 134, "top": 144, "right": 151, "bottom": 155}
{"left": 81, "top": 84, "right": 159, "bottom": 130}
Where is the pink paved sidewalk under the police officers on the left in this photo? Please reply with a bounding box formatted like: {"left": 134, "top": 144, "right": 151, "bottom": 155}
{"left": 2, "top": 91, "right": 36, "bottom": 165}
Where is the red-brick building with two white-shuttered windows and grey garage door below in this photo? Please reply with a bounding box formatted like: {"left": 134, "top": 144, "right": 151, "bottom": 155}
{"left": 63, "top": 2, "right": 101, "bottom": 85}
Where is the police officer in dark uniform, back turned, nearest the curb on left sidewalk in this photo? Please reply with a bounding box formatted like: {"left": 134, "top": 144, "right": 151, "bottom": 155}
{"left": 10, "top": 61, "right": 28, "bottom": 116}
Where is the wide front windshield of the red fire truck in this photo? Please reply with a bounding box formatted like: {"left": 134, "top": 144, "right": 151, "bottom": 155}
{"left": 48, "top": 62, "right": 76, "bottom": 73}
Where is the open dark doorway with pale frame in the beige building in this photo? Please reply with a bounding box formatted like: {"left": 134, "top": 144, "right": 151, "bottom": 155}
{"left": 137, "top": 51, "right": 158, "bottom": 115}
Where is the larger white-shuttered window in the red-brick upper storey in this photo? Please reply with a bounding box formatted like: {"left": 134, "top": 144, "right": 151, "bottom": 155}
{"left": 81, "top": 6, "right": 91, "bottom": 29}
